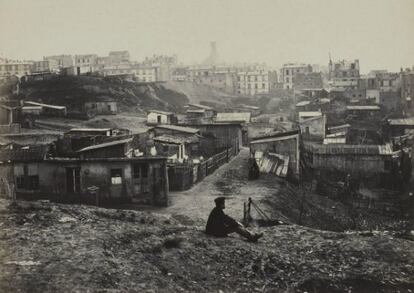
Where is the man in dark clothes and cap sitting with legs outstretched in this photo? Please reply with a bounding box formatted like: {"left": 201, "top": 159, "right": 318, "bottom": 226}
{"left": 206, "top": 197, "right": 263, "bottom": 242}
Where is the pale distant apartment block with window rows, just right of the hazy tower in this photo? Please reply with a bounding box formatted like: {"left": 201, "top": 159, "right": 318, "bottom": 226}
{"left": 236, "top": 70, "right": 269, "bottom": 96}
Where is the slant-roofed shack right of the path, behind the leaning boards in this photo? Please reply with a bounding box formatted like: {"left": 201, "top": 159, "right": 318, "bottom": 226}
{"left": 250, "top": 130, "right": 300, "bottom": 176}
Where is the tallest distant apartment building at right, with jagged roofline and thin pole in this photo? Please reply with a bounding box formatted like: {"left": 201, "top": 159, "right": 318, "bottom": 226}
{"left": 329, "top": 59, "right": 360, "bottom": 89}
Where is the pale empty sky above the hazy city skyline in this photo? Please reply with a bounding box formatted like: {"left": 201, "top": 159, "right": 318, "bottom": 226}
{"left": 0, "top": 0, "right": 414, "bottom": 72}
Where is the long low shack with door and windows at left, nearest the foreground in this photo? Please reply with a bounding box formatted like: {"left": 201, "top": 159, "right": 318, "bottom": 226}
{"left": 0, "top": 140, "right": 168, "bottom": 205}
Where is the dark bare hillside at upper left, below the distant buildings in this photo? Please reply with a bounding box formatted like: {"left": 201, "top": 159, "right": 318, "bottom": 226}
{"left": 20, "top": 76, "right": 188, "bottom": 112}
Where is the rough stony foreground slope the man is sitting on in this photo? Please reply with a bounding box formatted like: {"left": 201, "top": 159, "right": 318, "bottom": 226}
{"left": 0, "top": 200, "right": 414, "bottom": 292}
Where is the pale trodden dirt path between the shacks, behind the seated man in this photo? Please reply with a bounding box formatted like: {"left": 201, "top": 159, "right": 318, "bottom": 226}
{"left": 159, "top": 148, "right": 279, "bottom": 223}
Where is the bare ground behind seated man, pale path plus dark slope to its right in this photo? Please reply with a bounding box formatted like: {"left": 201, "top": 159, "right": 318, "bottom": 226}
{"left": 155, "top": 148, "right": 399, "bottom": 232}
